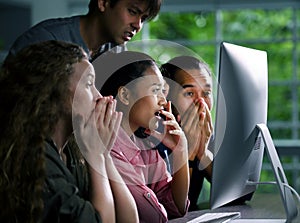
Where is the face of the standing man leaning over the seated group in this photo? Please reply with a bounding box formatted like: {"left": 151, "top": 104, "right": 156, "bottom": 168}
{"left": 101, "top": 0, "right": 148, "bottom": 44}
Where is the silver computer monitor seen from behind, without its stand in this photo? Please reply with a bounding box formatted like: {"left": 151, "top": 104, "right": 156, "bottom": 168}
{"left": 210, "top": 42, "right": 268, "bottom": 209}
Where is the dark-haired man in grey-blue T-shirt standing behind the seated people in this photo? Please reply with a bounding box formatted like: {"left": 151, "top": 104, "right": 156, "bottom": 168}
{"left": 9, "top": 0, "right": 162, "bottom": 61}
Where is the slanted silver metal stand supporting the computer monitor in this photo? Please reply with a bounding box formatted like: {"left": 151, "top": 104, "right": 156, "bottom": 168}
{"left": 232, "top": 124, "right": 298, "bottom": 223}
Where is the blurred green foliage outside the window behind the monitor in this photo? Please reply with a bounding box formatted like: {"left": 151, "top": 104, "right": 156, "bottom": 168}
{"left": 135, "top": 8, "right": 300, "bottom": 196}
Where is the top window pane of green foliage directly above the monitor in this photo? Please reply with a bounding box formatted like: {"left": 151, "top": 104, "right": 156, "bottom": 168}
{"left": 222, "top": 9, "right": 293, "bottom": 39}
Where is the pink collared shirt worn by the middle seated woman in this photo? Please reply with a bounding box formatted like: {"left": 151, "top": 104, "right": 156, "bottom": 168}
{"left": 111, "top": 128, "right": 189, "bottom": 223}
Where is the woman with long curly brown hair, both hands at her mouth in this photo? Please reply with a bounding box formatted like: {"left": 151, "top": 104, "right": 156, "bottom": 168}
{"left": 0, "top": 40, "right": 137, "bottom": 223}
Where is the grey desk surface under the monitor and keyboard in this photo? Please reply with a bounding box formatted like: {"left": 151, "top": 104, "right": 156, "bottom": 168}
{"left": 168, "top": 193, "right": 300, "bottom": 223}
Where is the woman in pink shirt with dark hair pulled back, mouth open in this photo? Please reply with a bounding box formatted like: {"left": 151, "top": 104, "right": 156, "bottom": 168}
{"left": 101, "top": 51, "right": 189, "bottom": 223}
